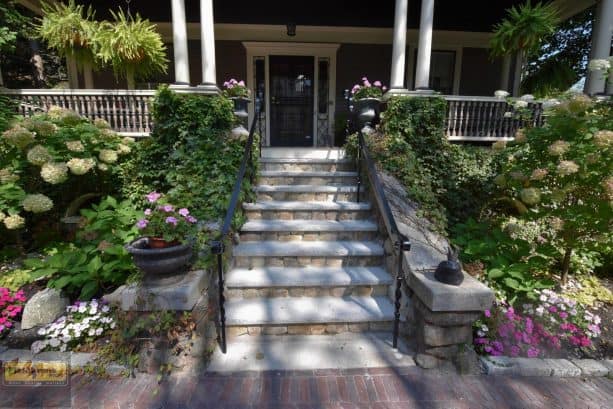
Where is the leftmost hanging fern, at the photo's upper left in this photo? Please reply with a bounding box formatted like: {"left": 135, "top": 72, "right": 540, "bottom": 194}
{"left": 35, "top": 0, "right": 98, "bottom": 67}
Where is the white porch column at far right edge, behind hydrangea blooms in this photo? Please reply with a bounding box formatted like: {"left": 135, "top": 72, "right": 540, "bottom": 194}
{"left": 585, "top": 0, "right": 613, "bottom": 94}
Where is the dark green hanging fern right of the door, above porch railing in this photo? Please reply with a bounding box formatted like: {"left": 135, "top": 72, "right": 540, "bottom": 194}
{"left": 490, "top": 0, "right": 560, "bottom": 91}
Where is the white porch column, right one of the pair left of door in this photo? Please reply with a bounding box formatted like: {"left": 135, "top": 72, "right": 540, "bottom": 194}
{"left": 199, "top": 0, "right": 219, "bottom": 92}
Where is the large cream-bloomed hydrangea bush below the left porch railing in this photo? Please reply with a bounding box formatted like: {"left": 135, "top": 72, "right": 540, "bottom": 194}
{"left": 0, "top": 107, "right": 134, "bottom": 237}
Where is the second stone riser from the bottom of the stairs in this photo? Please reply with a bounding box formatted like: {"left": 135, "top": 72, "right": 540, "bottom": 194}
{"left": 224, "top": 285, "right": 389, "bottom": 300}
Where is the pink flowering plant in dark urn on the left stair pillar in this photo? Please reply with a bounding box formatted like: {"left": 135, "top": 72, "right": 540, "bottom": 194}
{"left": 136, "top": 192, "right": 198, "bottom": 243}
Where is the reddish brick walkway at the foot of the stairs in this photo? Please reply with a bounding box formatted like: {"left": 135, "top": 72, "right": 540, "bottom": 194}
{"left": 0, "top": 367, "right": 613, "bottom": 409}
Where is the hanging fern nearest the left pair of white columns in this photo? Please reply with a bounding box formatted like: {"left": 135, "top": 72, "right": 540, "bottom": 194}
{"left": 95, "top": 8, "right": 168, "bottom": 89}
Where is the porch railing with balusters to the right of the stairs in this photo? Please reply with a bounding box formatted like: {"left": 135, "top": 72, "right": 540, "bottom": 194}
{"left": 443, "top": 95, "right": 543, "bottom": 142}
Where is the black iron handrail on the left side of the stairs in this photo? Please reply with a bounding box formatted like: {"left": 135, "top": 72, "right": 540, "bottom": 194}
{"left": 211, "top": 101, "right": 262, "bottom": 354}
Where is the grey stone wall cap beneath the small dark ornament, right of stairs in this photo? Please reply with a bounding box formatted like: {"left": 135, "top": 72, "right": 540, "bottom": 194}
{"left": 404, "top": 253, "right": 494, "bottom": 312}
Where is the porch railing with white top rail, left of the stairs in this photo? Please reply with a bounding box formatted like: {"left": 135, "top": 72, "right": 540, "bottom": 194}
{"left": 0, "top": 89, "right": 155, "bottom": 136}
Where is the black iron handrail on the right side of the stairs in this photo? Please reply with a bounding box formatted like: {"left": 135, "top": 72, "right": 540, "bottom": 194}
{"left": 357, "top": 130, "right": 411, "bottom": 348}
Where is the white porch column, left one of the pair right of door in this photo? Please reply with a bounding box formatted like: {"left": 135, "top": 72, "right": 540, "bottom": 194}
{"left": 388, "top": 0, "right": 409, "bottom": 94}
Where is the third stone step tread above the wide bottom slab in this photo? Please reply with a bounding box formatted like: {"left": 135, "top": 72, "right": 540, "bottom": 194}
{"left": 234, "top": 241, "right": 384, "bottom": 257}
